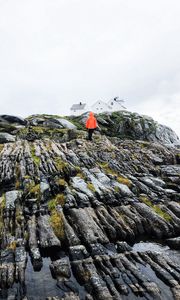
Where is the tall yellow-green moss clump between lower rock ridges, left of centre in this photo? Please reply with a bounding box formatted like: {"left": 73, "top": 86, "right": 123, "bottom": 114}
{"left": 50, "top": 209, "right": 65, "bottom": 240}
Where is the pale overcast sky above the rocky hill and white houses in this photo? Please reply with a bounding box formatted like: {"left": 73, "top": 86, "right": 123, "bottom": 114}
{"left": 0, "top": 0, "right": 180, "bottom": 136}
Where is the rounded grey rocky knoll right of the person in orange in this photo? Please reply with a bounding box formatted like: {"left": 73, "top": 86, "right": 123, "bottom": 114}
{"left": 95, "top": 111, "right": 180, "bottom": 146}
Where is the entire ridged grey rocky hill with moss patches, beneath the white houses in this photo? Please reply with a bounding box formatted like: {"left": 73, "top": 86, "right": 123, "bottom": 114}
{"left": 0, "top": 112, "right": 180, "bottom": 300}
